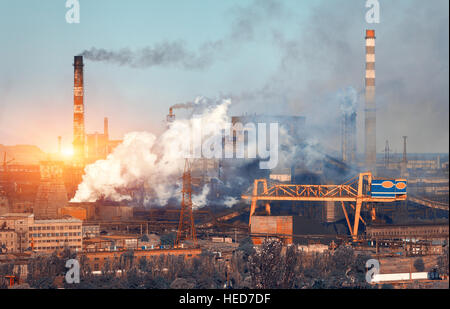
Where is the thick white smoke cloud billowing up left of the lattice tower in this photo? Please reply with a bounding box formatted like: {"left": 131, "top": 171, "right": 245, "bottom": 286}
{"left": 72, "top": 98, "right": 231, "bottom": 207}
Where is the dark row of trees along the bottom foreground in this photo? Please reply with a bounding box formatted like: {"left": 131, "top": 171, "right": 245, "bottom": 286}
{"left": 0, "top": 239, "right": 448, "bottom": 289}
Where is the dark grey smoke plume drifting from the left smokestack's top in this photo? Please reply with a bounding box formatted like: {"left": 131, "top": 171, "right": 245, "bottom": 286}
{"left": 80, "top": 0, "right": 285, "bottom": 70}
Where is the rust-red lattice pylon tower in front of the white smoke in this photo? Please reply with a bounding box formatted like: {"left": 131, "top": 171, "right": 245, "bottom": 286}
{"left": 175, "top": 159, "right": 197, "bottom": 248}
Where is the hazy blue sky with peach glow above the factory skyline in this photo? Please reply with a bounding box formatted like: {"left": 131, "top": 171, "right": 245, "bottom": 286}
{"left": 0, "top": 0, "right": 449, "bottom": 152}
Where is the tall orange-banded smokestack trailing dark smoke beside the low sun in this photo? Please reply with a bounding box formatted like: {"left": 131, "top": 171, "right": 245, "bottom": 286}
{"left": 73, "top": 56, "right": 85, "bottom": 162}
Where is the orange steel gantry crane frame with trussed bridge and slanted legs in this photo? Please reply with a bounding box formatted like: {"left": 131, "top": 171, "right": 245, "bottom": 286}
{"left": 242, "top": 172, "right": 406, "bottom": 241}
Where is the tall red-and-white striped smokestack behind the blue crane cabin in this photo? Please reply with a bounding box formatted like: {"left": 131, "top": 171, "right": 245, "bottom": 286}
{"left": 365, "top": 30, "right": 377, "bottom": 173}
